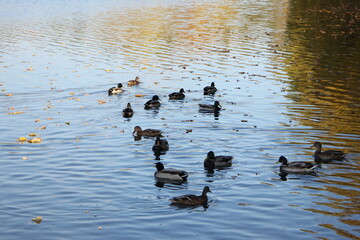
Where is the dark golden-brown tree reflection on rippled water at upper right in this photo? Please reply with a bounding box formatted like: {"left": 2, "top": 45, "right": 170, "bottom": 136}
{"left": 285, "top": 1, "right": 360, "bottom": 152}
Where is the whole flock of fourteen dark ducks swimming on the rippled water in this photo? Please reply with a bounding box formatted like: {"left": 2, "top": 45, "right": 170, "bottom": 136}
{"left": 108, "top": 77, "right": 346, "bottom": 205}
